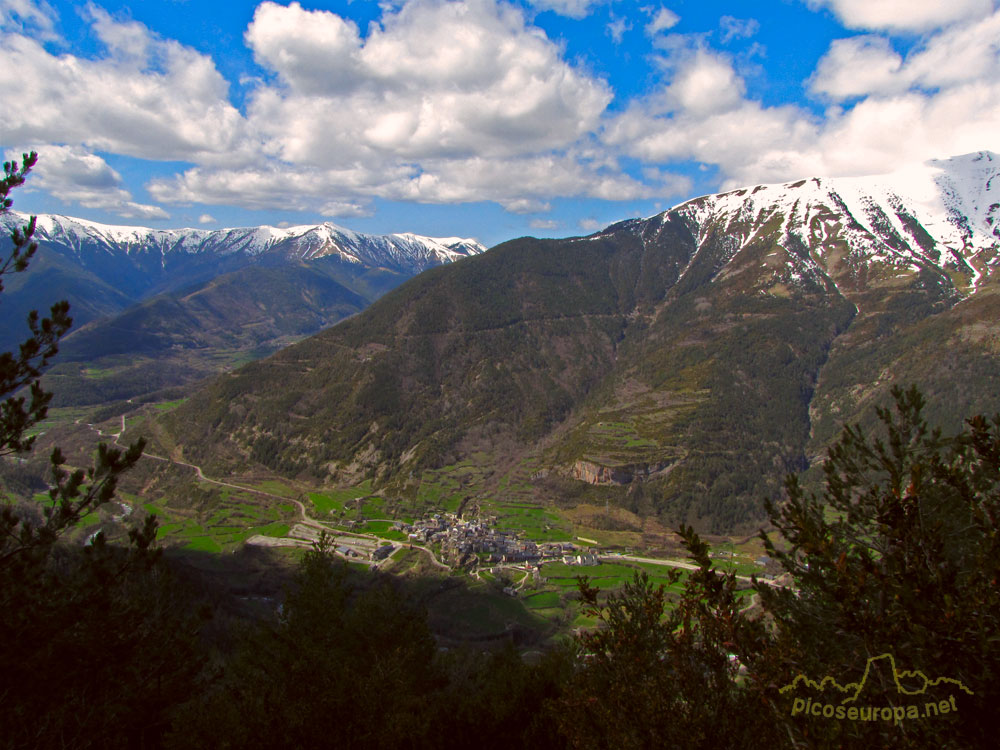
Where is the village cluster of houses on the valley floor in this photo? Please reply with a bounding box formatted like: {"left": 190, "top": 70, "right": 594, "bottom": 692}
{"left": 395, "top": 513, "right": 598, "bottom": 565}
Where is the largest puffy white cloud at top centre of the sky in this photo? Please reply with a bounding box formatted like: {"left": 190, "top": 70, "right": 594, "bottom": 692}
{"left": 246, "top": 0, "right": 611, "bottom": 166}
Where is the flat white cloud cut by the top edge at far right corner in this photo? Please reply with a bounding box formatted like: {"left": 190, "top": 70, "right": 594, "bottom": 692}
{"left": 808, "top": 0, "right": 995, "bottom": 32}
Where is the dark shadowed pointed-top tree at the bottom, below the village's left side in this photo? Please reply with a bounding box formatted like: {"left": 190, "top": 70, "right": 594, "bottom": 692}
{"left": 171, "top": 537, "right": 441, "bottom": 748}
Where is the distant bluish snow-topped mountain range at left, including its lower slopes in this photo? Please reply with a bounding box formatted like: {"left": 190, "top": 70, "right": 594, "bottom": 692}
{"left": 0, "top": 212, "right": 485, "bottom": 405}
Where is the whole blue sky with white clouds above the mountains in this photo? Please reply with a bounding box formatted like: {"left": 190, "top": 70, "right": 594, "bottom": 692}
{"left": 0, "top": 0, "right": 1000, "bottom": 245}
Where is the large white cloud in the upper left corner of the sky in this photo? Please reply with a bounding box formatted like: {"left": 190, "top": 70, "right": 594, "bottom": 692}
{"left": 0, "top": 6, "right": 247, "bottom": 161}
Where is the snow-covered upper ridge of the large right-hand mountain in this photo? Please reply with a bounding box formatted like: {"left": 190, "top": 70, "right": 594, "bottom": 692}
{"left": 645, "top": 151, "right": 1000, "bottom": 294}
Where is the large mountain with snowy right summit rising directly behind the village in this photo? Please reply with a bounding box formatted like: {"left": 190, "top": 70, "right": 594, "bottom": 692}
{"left": 161, "top": 153, "right": 1000, "bottom": 531}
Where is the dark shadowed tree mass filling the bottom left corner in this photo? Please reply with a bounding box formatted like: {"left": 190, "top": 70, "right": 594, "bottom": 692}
{"left": 0, "top": 517, "right": 208, "bottom": 750}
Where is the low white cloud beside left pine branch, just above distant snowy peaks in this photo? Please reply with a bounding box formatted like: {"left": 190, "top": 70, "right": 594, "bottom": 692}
{"left": 13, "top": 145, "right": 170, "bottom": 219}
